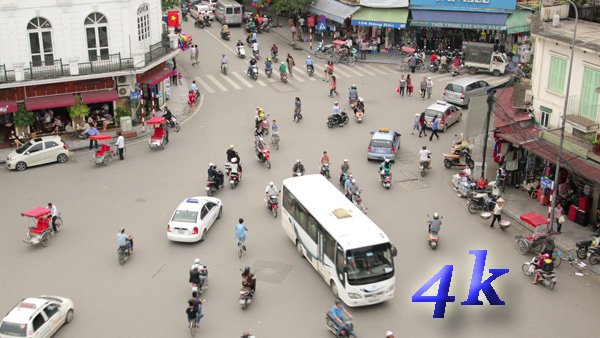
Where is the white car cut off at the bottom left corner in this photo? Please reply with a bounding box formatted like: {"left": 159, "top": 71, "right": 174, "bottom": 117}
{"left": 0, "top": 296, "right": 75, "bottom": 338}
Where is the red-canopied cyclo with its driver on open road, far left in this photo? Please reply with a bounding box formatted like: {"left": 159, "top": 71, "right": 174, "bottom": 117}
{"left": 21, "top": 207, "right": 62, "bottom": 246}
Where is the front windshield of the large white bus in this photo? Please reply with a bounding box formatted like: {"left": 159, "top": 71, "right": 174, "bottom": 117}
{"left": 346, "top": 243, "right": 394, "bottom": 285}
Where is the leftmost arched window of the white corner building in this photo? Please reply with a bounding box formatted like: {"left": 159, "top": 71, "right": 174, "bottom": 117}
{"left": 27, "top": 17, "right": 54, "bottom": 67}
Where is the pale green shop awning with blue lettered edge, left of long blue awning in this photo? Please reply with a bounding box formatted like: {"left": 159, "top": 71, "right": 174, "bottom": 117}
{"left": 352, "top": 7, "right": 408, "bottom": 28}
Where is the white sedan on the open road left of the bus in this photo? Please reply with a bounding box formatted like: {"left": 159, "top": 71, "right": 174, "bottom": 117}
{"left": 167, "top": 196, "right": 223, "bottom": 242}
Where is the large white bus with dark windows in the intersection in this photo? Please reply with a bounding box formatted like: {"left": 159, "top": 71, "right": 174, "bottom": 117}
{"left": 281, "top": 175, "right": 396, "bottom": 306}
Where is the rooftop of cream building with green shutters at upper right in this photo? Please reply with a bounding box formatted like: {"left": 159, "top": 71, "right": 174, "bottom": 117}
{"left": 531, "top": 15, "right": 600, "bottom": 53}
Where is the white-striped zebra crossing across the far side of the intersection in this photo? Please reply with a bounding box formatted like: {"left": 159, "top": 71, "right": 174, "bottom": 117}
{"left": 193, "top": 62, "right": 504, "bottom": 94}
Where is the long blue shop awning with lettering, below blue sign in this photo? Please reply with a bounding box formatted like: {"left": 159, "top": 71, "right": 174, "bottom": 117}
{"left": 409, "top": 10, "right": 508, "bottom": 30}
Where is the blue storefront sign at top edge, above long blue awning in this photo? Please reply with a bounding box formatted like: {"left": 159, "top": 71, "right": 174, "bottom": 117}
{"left": 410, "top": 0, "right": 517, "bottom": 13}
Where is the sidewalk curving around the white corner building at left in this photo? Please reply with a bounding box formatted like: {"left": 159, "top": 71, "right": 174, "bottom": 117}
{"left": 0, "top": 65, "right": 192, "bottom": 164}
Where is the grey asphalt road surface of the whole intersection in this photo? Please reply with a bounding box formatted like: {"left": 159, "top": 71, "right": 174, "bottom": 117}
{"left": 0, "top": 22, "right": 600, "bottom": 338}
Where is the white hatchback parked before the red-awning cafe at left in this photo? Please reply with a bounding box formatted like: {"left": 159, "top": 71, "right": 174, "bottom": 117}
{"left": 6, "top": 136, "right": 69, "bottom": 171}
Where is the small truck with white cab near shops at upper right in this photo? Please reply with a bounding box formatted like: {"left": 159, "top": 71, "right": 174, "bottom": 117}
{"left": 465, "top": 42, "right": 508, "bottom": 76}
